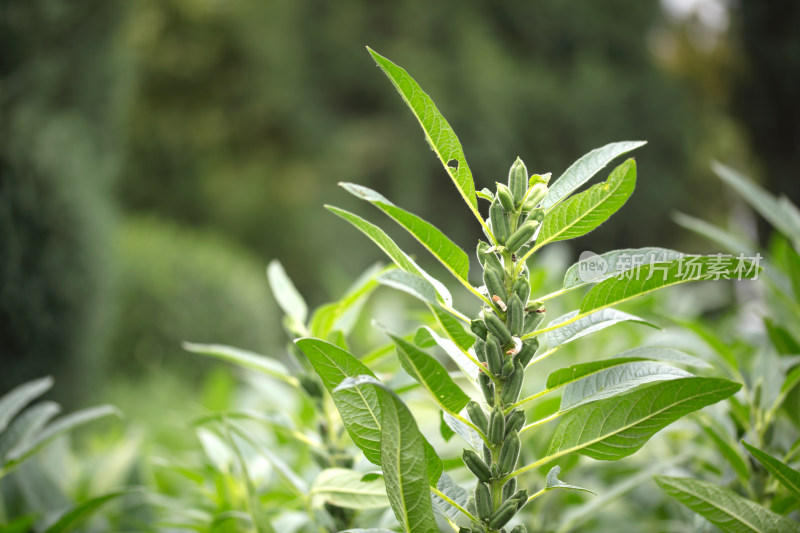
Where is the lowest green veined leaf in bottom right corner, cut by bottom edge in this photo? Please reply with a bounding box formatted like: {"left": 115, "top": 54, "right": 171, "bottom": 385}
{"left": 654, "top": 476, "right": 800, "bottom": 533}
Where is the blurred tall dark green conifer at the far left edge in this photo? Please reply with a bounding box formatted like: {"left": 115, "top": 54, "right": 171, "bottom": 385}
{"left": 0, "top": 0, "right": 125, "bottom": 391}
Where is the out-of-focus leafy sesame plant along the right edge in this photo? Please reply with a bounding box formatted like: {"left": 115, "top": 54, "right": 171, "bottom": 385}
{"left": 656, "top": 163, "right": 800, "bottom": 533}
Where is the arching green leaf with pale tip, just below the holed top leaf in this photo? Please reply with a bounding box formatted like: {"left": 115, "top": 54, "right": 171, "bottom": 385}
{"left": 339, "top": 183, "right": 469, "bottom": 283}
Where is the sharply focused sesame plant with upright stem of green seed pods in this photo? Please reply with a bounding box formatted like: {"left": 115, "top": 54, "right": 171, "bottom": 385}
{"left": 296, "top": 50, "right": 758, "bottom": 533}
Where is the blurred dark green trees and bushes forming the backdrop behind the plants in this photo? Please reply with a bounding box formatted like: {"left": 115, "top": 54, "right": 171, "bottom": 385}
{"left": 0, "top": 0, "right": 800, "bottom": 403}
